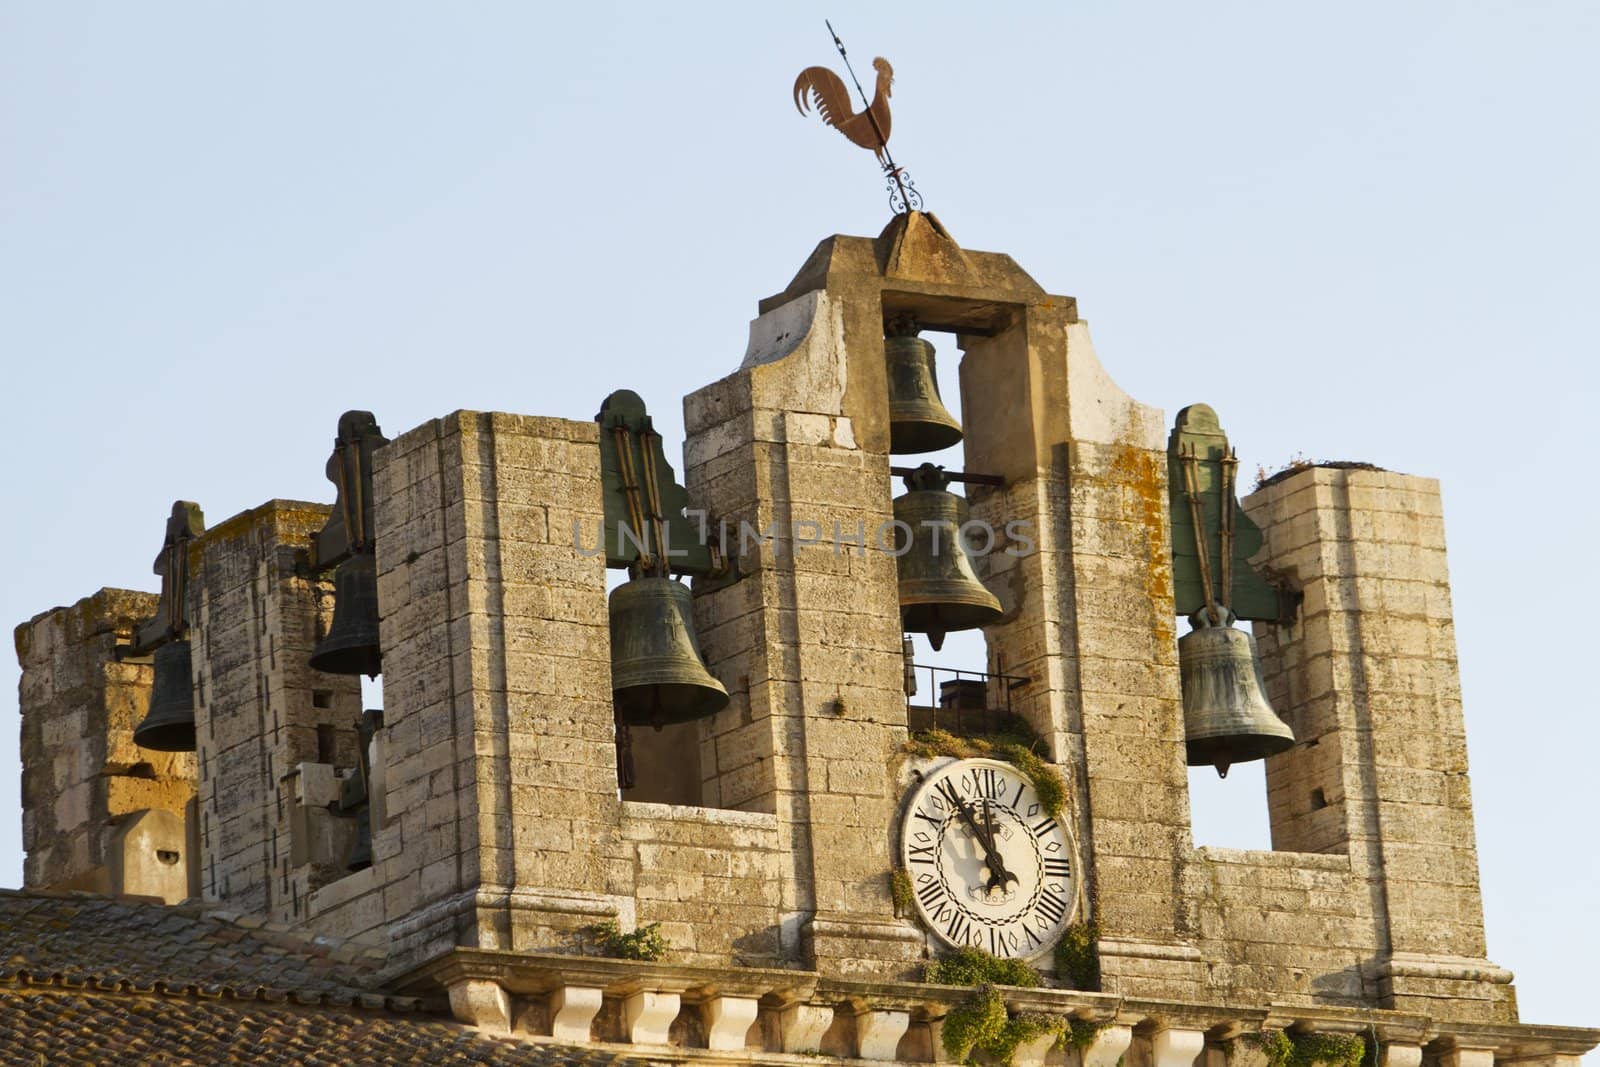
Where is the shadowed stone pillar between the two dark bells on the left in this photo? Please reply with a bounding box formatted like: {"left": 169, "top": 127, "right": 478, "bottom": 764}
{"left": 189, "top": 501, "right": 362, "bottom": 921}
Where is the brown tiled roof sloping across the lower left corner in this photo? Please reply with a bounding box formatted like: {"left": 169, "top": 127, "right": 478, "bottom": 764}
{"left": 0, "top": 889, "right": 638, "bottom": 1067}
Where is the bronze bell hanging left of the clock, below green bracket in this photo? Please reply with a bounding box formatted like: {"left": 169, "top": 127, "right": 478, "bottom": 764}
{"left": 611, "top": 577, "right": 728, "bottom": 726}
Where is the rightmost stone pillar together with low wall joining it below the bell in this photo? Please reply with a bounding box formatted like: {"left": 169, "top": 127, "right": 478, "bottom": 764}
{"left": 1189, "top": 467, "right": 1515, "bottom": 1021}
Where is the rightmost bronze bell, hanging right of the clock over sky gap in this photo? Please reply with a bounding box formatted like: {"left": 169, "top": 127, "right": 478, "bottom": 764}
{"left": 1178, "top": 608, "right": 1294, "bottom": 777}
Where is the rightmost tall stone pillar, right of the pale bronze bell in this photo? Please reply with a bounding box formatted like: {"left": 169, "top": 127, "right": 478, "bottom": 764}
{"left": 1245, "top": 467, "right": 1515, "bottom": 1021}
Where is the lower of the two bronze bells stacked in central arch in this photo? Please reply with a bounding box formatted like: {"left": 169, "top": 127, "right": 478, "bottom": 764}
{"left": 894, "top": 464, "right": 1002, "bottom": 649}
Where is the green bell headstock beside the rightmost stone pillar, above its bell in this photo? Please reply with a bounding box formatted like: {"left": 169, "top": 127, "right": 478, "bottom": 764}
{"left": 1166, "top": 403, "right": 1290, "bottom": 622}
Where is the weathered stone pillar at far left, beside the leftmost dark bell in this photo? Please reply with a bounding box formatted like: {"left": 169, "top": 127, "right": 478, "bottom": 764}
{"left": 16, "top": 589, "right": 195, "bottom": 904}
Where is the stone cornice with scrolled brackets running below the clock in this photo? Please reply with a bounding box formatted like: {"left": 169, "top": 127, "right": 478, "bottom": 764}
{"left": 397, "top": 949, "right": 1592, "bottom": 1067}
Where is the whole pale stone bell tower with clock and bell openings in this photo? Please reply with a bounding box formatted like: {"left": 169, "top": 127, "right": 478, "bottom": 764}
{"left": 19, "top": 211, "right": 1600, "bottom": 1067}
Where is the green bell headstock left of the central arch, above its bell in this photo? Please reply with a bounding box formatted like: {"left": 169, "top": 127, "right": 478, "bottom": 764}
{"left": 595, "top": 389, "right": 728, "bottom": 577}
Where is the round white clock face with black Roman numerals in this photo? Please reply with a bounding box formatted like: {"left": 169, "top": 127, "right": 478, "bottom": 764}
{"left": 901, "top": 760, "right": 1078, "bottom": 958}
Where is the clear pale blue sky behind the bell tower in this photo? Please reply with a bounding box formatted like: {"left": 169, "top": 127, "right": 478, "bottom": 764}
{"left": 0, "top": 3, "right": 1600, "bottom": 1024}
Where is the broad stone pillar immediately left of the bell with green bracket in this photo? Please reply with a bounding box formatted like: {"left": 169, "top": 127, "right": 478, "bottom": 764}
{"left": 356, "top": 411, "right": 632, "bottom": 958}
